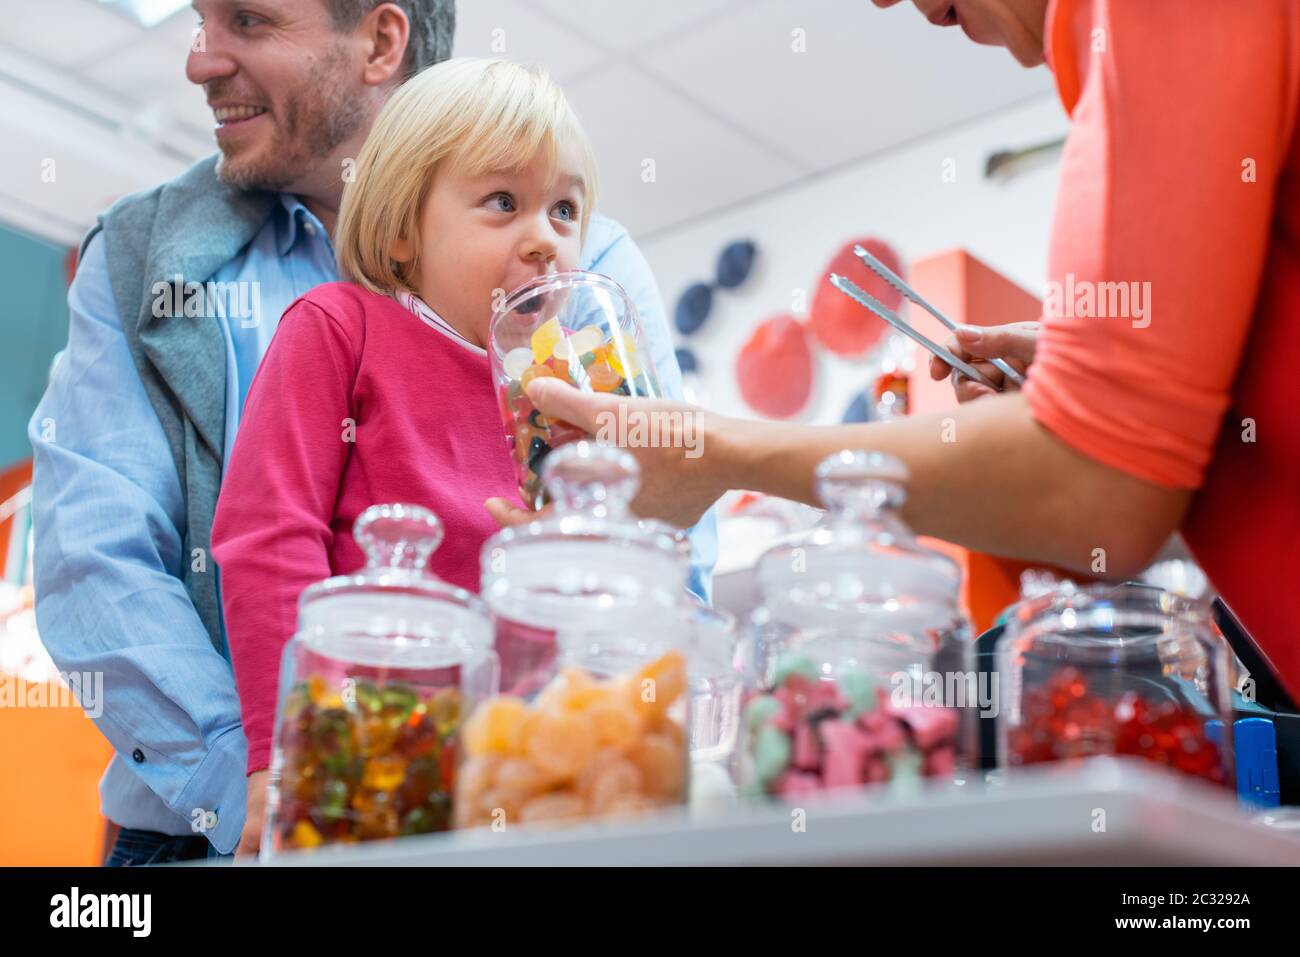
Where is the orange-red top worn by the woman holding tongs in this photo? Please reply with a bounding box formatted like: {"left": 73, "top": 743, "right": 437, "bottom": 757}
{"left": 1026, "top": 0, "right": 1300, "bottom": 700}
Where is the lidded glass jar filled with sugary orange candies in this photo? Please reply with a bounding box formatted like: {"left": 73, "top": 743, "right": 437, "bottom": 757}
{"left": 456, "top": 442, "right": 690, "bottom": 828}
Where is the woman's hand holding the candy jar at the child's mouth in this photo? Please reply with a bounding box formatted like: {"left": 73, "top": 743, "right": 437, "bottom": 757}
{"left": 485, "top": 378, "right": 729, "bottom": 528}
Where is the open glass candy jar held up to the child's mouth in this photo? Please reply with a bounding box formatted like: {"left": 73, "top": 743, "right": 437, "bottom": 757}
{"left": 488, "top": 272, "right": 662, "bottom": 508}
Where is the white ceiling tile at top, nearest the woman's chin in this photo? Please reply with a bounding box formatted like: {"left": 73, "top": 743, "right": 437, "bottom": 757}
{"left": 638, "top": 0, "right": 1052, "bottom": 170}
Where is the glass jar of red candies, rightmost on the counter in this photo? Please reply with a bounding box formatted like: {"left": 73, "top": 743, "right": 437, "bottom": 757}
{"left": 997, "top": 584, "right": 1234, "bottom": 784}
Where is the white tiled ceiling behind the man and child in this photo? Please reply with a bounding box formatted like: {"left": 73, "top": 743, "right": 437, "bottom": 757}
{"left": 0, "top": 0, "right": 1050, "bottom": 242}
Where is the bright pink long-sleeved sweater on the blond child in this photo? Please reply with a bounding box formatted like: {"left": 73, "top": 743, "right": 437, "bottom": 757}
{"left": 212, "top": 282, "right": 517, "bottom": 774}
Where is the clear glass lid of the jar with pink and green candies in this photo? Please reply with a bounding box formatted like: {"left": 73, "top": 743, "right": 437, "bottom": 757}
{"left": 758, "top": 450, "right": 961, "bottom": 636}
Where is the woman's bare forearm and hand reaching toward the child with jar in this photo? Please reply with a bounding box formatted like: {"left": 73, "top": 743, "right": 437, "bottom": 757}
{"left": 490, "top": 380, "right": 1190, "bottom": 576}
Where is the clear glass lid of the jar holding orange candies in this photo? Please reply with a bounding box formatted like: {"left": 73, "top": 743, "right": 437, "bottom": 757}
{"left": 482, "top": 441, "right": 690, "bottom": 628}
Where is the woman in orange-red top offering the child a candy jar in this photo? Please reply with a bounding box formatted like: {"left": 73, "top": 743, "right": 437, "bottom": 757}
{"left": 490, "top": 0, "right": 1300, "bottom": 698}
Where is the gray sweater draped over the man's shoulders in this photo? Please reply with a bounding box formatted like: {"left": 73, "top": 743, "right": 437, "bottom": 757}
{"left": 82, "top": 155, "right": 283, "bottom": 655}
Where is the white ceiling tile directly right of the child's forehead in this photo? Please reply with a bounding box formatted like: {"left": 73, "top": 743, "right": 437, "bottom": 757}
{"left": 567, "top": 66, "right": 798, "bottom": 233}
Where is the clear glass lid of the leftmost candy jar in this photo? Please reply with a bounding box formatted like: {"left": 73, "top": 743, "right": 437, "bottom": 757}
{"left": 298, "top": 505, "right": 491, "bottom": 657}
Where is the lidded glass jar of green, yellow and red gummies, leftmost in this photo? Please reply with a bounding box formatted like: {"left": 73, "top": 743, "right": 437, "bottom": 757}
{"left": 261, "top": 505, "right": 497, "bottom": 858}
